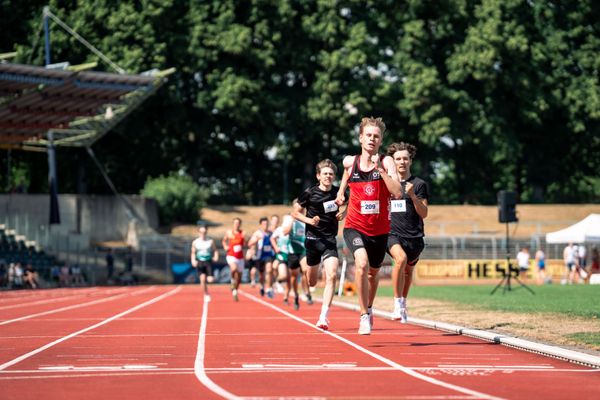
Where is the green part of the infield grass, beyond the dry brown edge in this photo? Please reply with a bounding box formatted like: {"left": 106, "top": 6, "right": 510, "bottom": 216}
{"left": 377, "top": 284, "right": 600, "bottom": 319}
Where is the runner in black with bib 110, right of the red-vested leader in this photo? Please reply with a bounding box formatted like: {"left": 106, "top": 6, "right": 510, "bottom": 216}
{"left": 387, "top": 142, "right": 429, "bottom": 323}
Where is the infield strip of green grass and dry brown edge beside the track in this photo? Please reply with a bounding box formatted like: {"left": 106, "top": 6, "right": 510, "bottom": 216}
{"left": 376, "top": 285, "right": 600, "bottom": 352}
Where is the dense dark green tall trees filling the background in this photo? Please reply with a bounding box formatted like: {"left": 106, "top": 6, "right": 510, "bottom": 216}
{"left": 0, "top": 0, "right": 600, "bottom": 204}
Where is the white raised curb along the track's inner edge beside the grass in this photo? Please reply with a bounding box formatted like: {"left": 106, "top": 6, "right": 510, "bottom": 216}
{"left": 333, "top": 300, "right": 600, "bottom": 369}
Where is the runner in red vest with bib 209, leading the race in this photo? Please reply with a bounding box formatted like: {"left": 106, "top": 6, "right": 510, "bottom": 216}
{"left": 336, "top": 117, "right": 402, "bottom": 335}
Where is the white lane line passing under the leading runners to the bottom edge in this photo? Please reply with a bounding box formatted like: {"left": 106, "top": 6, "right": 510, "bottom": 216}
{"left": 238, "top": 291, "right": 502, "bottom": 400}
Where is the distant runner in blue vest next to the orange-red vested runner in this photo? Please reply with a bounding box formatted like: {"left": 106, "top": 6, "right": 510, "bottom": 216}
{"left": 248, "top": 217, "right": 275, "bottom": 299}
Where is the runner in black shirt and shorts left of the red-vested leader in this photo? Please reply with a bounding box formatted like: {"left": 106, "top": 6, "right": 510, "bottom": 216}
{"left": 292, "top": 159, "right": 343, "bottom": 330}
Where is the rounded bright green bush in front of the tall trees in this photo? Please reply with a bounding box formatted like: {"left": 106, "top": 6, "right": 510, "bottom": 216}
{"left": 142, "top": 172, "right": 209, "bottom": 225}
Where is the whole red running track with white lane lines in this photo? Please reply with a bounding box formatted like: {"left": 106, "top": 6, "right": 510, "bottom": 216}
{"left": 0, "top": 286, "right": 600, "bottom": 400}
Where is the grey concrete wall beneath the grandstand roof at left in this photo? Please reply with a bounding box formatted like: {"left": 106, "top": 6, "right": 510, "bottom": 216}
{"left": 0, "top": 194, "right": 158, "bottom": 242}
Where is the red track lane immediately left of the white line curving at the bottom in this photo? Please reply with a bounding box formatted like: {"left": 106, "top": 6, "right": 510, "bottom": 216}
{"left": 0, "top": 287, "right": 218, "bottom": 400}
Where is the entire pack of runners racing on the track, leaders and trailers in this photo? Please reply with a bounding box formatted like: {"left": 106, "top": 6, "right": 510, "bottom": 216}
{"left": 191, "top": 118, "right": 429, "bottom": 335}
